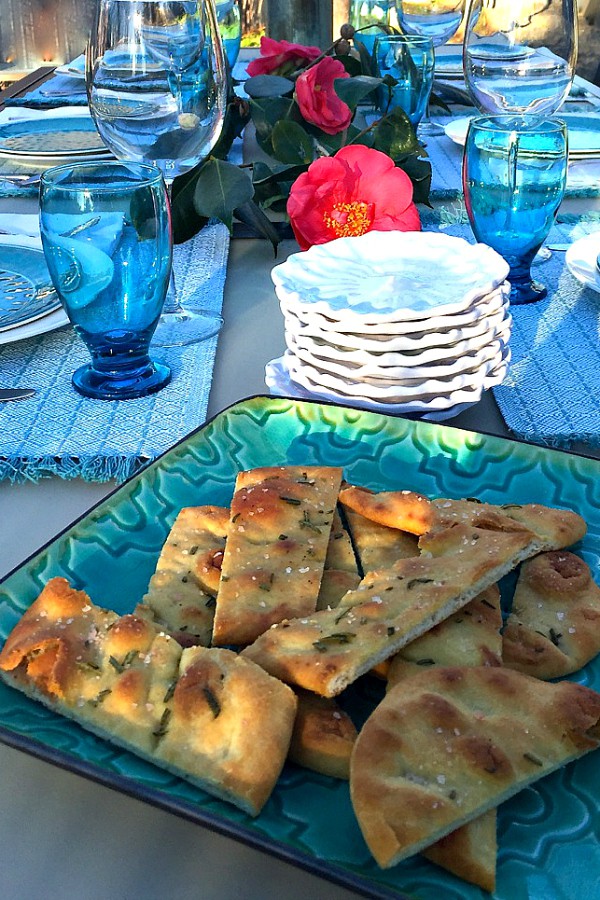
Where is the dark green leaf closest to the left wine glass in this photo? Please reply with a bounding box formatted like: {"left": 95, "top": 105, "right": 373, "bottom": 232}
{"left": 194, "top": 158, "right": 254, "bottom": 230}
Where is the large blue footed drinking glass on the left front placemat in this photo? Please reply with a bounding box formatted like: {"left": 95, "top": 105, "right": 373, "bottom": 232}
{"left": 40, "top": 161, "right": 172, "bottom": 400}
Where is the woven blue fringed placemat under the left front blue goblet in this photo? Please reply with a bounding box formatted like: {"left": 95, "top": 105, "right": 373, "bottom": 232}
{"left": 0, "top": 223, "right": 229, "bottom": 482}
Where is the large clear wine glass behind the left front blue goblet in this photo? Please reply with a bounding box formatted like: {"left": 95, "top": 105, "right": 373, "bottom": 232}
{"left": 86, "top": 0, "right": 227, "bottom": 347}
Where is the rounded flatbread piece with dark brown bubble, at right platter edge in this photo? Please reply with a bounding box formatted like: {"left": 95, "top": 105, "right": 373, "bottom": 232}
{"left": 502, "top": 550, "right": 600, "bottom": 679}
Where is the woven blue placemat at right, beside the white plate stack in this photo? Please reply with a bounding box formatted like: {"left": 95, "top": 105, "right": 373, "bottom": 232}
{"left": 423, "top": 210, "right": 600, "bottom": 447}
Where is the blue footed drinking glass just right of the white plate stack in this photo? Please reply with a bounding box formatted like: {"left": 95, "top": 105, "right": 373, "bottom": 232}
{"left": 463, "top": 115, "right": 567, "bottom": 304}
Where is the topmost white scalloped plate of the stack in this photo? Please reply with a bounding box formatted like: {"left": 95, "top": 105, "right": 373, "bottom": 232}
{"left": 271, "top": 231, "right": 509, "bottom": 331}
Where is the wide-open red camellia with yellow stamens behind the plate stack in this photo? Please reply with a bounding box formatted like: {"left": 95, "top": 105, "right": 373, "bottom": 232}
{"left": 287, "top": 144, "right": 421, "bottom": 250}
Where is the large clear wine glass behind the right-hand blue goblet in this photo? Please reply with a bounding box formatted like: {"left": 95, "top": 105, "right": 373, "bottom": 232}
{"left": 463, "top": 0, "right": 578, "bottom": 116}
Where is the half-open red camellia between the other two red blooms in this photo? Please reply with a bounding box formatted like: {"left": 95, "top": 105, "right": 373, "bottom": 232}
{"left": 296, "top": 56, "right": 352, "bottom": 134}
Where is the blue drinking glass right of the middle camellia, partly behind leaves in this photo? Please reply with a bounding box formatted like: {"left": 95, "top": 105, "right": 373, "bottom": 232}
{"left": 373, "top": 34, "right": 435, "bottom": 128}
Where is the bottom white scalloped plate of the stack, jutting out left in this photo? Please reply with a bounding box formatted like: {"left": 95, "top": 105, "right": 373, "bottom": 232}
{"left": 265, "top": 349, "right": 510, "bottom": 422}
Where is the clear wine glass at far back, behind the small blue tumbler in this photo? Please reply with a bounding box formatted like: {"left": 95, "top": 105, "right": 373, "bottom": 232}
{"left": 396, "top": 0, "right": 464, "bottom": 135}
